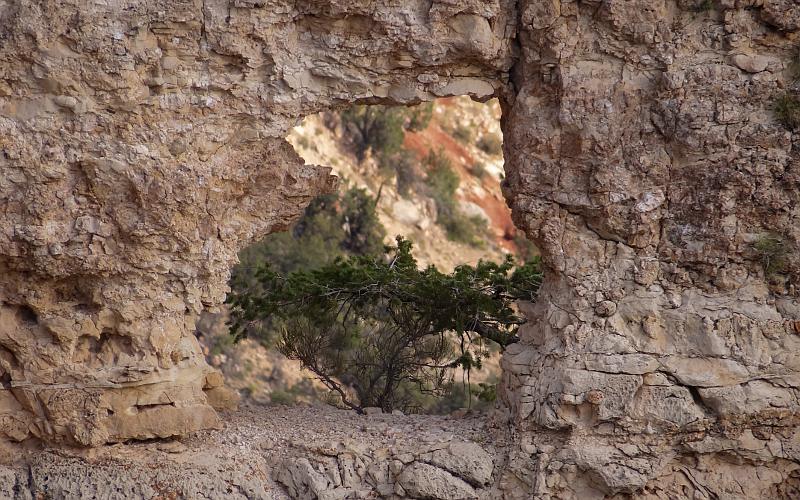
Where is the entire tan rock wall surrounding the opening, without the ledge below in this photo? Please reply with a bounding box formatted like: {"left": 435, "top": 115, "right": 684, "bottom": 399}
{"left": 0, "top": 0, "right": 800, "bottom": 498}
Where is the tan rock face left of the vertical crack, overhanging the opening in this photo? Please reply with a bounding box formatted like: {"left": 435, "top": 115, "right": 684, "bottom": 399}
{"left": 0, "top": 0, "right": 516, "bottom": 445}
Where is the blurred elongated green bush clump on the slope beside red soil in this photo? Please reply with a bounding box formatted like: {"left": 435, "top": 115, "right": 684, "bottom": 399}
{"left": 425, "top": 150, "right": 486, "bottom": 247}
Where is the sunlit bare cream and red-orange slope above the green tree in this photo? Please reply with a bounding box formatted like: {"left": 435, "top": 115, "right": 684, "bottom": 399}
{"left": 288, "top": 97, "right": 517, "bottom": 269}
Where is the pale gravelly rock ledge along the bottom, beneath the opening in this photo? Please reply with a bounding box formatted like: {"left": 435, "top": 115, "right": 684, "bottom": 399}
{"left": 0, "top": 405, "right": 504, "bottom": 500}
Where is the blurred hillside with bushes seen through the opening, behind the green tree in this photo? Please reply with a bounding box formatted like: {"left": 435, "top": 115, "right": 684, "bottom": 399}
{"left": 198, "top": 97, "right": 537, "bottom": 414}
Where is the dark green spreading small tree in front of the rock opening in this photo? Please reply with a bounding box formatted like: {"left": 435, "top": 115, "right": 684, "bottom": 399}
{"left": 229, "top": 237, "right": 541, "bottom": 411}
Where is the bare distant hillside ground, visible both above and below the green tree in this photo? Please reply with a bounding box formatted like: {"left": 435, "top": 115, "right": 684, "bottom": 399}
{"left": 199, "top": 97, "right": 527, "bottom": 407}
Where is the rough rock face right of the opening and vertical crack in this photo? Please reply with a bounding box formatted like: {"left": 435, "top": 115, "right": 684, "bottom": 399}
{"left": 503, "top": 0, "right": 800, "bottom": 498}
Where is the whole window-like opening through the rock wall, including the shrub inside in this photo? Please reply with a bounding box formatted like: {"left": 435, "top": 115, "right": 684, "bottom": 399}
{"left": 198, "top": 97, "right": 539, "bottom": 414}
